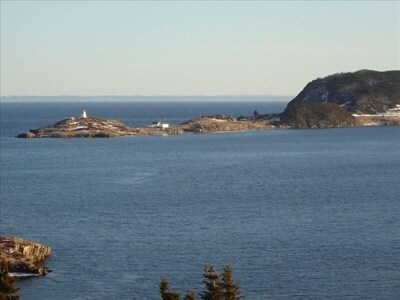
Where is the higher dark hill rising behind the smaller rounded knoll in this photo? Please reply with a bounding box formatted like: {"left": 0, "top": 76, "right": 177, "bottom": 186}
{"left": 287, "top": 70, "right": 400, "bottom": 114}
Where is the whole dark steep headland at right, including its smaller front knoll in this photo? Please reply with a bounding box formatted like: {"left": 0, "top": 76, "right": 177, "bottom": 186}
{"left": 281, "top": 70, "right": 400, "bottom": 128}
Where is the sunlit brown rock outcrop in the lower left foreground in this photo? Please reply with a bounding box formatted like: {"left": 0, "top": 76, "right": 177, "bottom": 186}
{"left": 0, "top": 237, "right": 51, "bottom": 276}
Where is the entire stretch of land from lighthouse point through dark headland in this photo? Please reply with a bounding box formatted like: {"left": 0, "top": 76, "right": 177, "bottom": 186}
{"left": 17, "top": 70, "right": 400, "bottom": 138}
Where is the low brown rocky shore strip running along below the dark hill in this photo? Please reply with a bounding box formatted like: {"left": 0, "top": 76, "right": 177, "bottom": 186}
{"left": 17, "top": 110, "right": 400, "bottom": 138}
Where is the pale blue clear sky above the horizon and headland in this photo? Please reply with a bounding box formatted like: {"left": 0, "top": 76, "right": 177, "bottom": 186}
{"left": 0, "top": 0, "right": 400, "bottom": 96}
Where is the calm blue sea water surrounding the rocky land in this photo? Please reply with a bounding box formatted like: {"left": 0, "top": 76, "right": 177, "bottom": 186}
{"left": 1, "top": 102, "right": 400, "bottom": 299}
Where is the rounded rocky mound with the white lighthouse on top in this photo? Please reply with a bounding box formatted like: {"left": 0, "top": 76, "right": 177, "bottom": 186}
{"left": 17, "top": 117, "right": 137, "bottom": 138}
